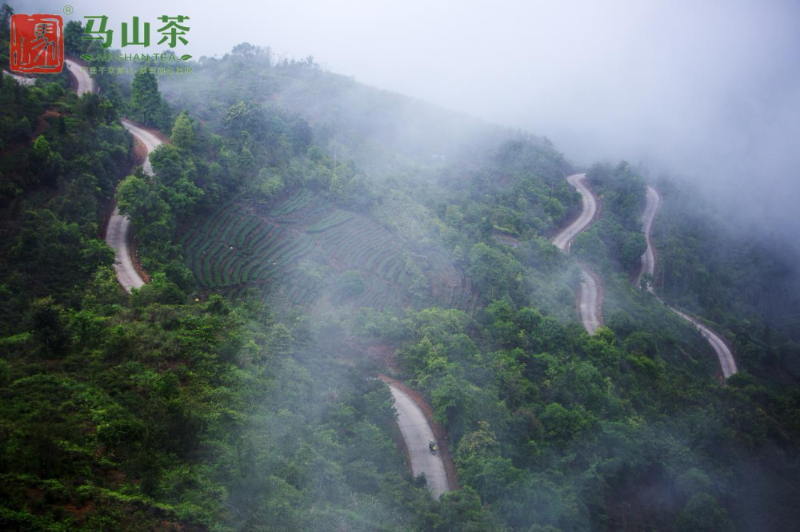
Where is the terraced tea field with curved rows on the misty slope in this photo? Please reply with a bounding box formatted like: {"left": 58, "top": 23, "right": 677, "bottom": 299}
{"left": 180, "top": 190, "right": 475, "bottom": 311}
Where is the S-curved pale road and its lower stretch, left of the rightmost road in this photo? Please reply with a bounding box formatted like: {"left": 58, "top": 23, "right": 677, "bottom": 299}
{"left": 553, "top": 174, "right": 603, "bottom": 334}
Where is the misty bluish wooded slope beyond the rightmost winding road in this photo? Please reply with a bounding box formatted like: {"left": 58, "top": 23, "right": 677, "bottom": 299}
{"left": 654, "top": 181, "right": 800, "bottom": 383}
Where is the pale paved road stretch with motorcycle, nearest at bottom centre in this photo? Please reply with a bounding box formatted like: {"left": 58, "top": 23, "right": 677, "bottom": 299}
{"left": 387, "top": 383, "right": 450, "bottom": 499}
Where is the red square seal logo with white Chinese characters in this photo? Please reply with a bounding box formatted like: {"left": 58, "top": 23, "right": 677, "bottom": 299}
{"left": 9, "top": 14, "right": 64, "bottom": 74}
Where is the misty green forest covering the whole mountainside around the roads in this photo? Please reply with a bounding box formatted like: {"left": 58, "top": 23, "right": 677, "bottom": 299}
{"left": 0, "top": 5, "right": 800, "bottom": 532}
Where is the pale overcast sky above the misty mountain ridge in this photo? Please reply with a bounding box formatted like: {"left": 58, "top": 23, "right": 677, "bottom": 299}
{"left": 21, "top": 0, "right": 800, "bottom": 240}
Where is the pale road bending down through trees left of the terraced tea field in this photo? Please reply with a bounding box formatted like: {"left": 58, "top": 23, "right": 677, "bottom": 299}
{"left": 106, "top": 120, "right": 161, "bottom": 292}
